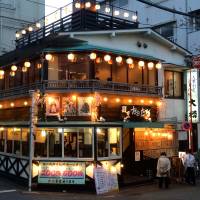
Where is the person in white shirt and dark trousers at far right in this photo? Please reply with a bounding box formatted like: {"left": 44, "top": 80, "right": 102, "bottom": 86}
{"left": 183, "top": 149, "right": 196, "bottom": 185}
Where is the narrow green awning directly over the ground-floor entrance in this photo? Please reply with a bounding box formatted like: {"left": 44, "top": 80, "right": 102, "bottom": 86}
{"left": 123, "top": 122, "right": 165, "bottom": 128}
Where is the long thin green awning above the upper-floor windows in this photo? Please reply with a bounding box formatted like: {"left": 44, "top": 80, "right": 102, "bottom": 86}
{"left": 44, "top": 44, "right": 163, "bottom": 61}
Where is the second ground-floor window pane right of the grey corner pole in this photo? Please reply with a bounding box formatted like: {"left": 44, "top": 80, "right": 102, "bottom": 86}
{"left": 48, "top": 129, "right": 62, "bottom": 157}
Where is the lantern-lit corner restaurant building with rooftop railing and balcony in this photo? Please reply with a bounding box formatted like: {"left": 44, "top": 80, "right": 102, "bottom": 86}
{"left": 0, "top": 2, "right": 191, "bottom": 187}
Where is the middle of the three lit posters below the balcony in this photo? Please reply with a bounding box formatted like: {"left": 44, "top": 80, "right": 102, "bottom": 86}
{"left": 62, "top": 97, "right": 77, "bottom": 116}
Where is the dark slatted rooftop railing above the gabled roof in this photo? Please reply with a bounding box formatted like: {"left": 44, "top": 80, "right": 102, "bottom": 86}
{"left": 16, "top": 9, "right": 138, "bottom": 48}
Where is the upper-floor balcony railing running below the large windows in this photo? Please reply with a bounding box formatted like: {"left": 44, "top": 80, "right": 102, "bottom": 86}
{"left": 0, "top": 80, "right": 162, "bottom": 98}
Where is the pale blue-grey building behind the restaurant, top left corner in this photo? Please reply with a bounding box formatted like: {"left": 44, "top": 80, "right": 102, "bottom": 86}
{"left": 0, "top": 0, "right": 45, "bottom": 55}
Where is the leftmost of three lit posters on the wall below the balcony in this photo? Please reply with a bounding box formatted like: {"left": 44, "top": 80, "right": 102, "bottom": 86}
{"left": 46, "top": 97, "right": 60, "bottom": 116}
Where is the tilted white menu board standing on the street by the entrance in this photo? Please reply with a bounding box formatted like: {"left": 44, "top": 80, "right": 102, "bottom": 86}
{"left": 94, "top": 168, "right": 119, "bottom": 194}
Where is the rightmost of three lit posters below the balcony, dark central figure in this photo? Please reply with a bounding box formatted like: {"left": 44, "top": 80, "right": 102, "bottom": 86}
{"left": 78, "top": 97, "right": 92, "bottom": 116}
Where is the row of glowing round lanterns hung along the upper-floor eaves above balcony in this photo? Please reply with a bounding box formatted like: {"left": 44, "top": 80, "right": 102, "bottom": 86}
{"left": 0, "top": 52, "right": 162, "bottom": 79}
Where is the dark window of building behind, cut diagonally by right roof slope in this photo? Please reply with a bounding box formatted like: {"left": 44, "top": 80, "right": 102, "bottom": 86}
{"left": 153, "top": 22, "right": 175, "bottom": 42}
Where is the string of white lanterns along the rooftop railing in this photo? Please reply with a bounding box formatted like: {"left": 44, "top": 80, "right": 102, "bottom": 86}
{"left": 15, "top": 1, "right": 138, "bottom": 39}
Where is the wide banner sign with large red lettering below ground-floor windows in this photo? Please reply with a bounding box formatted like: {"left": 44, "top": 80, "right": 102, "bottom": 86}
{"left": 38, "top": 162, "right": 85, "bottom": 185}
